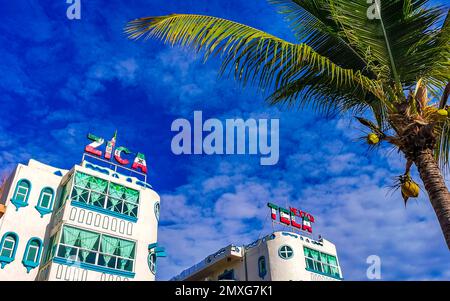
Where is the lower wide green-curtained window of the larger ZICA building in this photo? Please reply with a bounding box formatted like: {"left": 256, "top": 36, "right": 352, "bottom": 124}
{"left": 56, "top": 226, "right": 136, "bottom": 272}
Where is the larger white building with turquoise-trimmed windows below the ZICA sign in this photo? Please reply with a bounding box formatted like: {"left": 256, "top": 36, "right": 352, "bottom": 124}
{"left": 0, "top": 157, "right": 165, "bottom": 281}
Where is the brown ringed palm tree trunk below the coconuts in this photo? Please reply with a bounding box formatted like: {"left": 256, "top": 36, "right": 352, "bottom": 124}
{"left": 415, "top": 150, "right": 450, "bottom": 249}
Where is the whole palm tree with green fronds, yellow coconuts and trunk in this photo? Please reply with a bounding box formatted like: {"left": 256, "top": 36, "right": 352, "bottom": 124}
{"left": 125, "top": 0, "right": 450, "bottom": 248}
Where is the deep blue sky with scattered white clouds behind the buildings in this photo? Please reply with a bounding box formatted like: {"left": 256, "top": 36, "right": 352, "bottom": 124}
{"left": 0, "top": 0, "right": 450, "bottom": 280}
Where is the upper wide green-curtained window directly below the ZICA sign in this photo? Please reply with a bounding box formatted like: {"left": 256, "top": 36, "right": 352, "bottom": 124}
{"left": 71, "top": 172, "right": 139, "bottom": 221}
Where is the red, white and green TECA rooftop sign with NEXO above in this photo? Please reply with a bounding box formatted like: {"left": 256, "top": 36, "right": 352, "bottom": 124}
{"left": 267, "top": 203, "right": 314, "bottom": 233}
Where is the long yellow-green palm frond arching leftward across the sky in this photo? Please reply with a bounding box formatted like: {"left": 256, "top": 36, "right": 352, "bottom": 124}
{"left": 125, "top": 14, "right": 383, "bottom": 97}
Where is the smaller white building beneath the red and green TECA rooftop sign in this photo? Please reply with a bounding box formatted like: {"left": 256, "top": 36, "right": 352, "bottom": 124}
{"left": 172, "top": 231, "right": 343, "bottom": 281}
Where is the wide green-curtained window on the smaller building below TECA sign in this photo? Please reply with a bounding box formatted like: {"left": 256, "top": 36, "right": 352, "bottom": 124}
{"left": 303, "top": 247, "right": 340, "bottom": 278}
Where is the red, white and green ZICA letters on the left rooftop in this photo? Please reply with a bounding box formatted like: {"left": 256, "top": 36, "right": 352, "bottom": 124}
{"left": 84, "top": 131, "right": 147, "bottom": 174}
